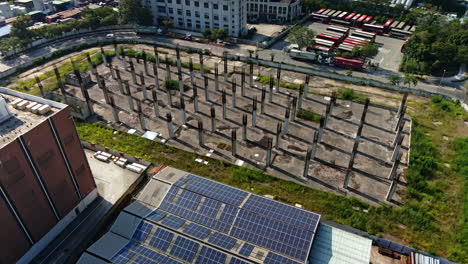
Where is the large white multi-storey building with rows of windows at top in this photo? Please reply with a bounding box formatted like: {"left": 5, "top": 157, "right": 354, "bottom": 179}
{"left": 142, "top": 0, "right": 247, "bottom": 37}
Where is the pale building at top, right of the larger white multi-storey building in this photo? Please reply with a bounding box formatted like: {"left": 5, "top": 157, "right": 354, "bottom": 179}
{"left": 247, "top": 0, "right": 301, "bottom": 23}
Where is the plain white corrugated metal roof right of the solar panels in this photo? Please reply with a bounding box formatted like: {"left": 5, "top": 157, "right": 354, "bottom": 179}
{"left": 310, "top": 224, "right": 372, "bottom": 264}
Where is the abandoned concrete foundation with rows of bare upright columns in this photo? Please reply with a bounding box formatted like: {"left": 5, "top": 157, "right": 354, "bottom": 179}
{"left": 34, "top": 45, "right": 412, "bottom": 205}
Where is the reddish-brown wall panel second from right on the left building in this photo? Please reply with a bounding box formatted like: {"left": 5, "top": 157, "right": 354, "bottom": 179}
{"left": 23, "top": 122, "right": 79, "bottom": 217}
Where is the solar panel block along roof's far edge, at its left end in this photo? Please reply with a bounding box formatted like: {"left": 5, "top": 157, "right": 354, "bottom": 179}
{"left": 185, "top": 175, "right": 247, "bottom": 206}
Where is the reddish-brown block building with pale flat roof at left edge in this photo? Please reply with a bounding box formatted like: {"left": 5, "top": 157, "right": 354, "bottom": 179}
{"left": 0, "top": 88, "right": 98, "bottom": 263}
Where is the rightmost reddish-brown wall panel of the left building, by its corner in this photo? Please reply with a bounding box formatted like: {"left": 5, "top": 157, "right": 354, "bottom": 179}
{"left": 52, "top": 107, "right": 96, "bottom": 198}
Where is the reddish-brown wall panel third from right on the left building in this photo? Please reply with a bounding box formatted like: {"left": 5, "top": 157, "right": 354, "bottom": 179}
{"left": 0, "top": 141, "right": 57, "bottom": 242}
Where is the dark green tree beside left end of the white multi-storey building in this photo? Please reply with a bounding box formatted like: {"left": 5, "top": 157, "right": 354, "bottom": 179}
{"left": 119, "top": 0, "right": 153, "bottom": 26}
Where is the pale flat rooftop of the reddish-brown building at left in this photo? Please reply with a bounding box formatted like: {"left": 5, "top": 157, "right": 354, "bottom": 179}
{"left": 0, "top": 87, "right": 66, "bottom": 148}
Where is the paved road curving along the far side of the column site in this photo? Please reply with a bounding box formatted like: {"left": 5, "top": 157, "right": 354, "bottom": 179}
{"left": 0, "top": 29, "right": 466, "bottom": 101}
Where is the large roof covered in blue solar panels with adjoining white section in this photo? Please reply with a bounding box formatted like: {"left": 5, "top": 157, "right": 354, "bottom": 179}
{"left": 78, "top": 167, "right": 371, "bottom": 264}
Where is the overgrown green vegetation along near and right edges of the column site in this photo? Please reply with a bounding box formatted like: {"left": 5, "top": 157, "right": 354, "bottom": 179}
{"left": 77, "top": 92, "right": 468, "bottom": 263}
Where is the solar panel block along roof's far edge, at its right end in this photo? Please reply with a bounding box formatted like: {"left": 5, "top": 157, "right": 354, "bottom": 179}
{"left": 242, "top": 195, "right": 320, "bottom": 231}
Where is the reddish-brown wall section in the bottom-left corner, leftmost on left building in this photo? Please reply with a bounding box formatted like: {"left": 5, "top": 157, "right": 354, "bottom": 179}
{"left": 0, "top": 194, "right": 30, "bottom": 263}
